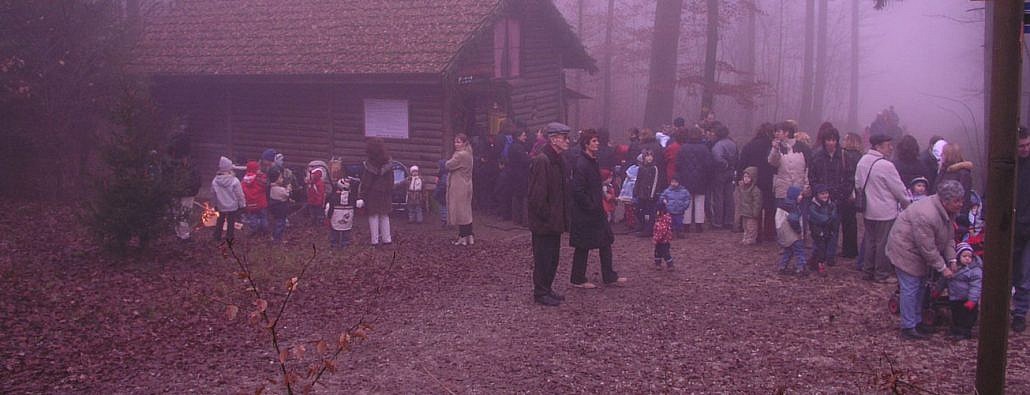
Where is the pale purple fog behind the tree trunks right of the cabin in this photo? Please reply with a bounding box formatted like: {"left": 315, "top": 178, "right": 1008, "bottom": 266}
{"left": 556, "top": 0, "right": 985, "bottom": 162}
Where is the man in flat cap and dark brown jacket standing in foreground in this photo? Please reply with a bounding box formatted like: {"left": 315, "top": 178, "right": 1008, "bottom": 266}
{"left": 526, "top": 122, "right": 569, "bottom": 306}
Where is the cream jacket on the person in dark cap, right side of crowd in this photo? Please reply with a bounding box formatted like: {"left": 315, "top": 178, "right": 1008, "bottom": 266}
{"left": 855, "top": 150, "right": 908, "bottom": 221}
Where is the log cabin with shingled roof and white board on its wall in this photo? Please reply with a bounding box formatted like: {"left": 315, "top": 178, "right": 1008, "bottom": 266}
{"left": 131, "top": 0, "right": 596, "bottom": 181}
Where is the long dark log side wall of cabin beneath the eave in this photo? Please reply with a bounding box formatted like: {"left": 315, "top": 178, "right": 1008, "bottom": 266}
{"left": 157, "top": 83, "right": 450, "bottom": 183}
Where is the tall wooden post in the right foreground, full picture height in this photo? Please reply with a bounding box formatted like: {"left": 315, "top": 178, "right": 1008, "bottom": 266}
{"left": 976, "top": 0, "right": 1023, "bottom": 394}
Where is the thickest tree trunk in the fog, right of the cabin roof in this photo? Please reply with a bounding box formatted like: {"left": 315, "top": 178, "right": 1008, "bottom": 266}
{"left": 644, "top": 0, "right": 683, "bottom": 128}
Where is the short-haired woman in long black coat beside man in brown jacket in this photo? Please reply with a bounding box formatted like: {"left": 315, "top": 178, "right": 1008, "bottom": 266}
{"left": 569, "top": 129, "right": 626, "bottom": 289}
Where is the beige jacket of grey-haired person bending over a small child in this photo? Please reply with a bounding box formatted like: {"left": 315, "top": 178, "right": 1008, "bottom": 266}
{"left": 878, "top": 195, "right": 955, "bottom": 276}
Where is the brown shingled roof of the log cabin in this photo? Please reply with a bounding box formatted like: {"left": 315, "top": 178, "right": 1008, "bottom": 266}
{"left": 133, "top": 0, "right": 595, "bottom": 75}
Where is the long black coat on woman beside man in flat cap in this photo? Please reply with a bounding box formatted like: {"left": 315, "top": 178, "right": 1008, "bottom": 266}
{"left": 569, "top": 153, "right": 615, "bottom": 250}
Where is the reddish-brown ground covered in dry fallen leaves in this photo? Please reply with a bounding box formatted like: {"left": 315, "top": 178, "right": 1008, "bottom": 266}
{"left": 0, "top": 202, "right": 1030, "bottom": 393}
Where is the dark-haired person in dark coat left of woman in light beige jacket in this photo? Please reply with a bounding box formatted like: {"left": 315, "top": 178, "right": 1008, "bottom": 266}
{"left": 737, "top": 123, "right": 776, "bottom": 241}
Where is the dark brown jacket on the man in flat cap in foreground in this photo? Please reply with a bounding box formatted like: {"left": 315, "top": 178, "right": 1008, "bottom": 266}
{"left": 526, "top": 145, "right": 569, "bottom": 235}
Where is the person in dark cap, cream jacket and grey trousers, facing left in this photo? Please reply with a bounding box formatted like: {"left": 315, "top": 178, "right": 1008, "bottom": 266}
{"left": 855, "top": 134, "right": 908, "bottom": 283}
